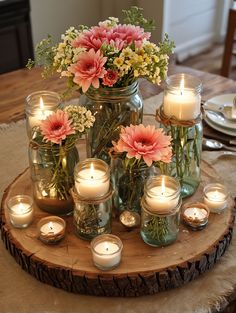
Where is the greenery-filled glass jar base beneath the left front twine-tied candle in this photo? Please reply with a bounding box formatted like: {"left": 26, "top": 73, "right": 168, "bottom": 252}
{"left": 73, "top": 190, "right": 112, "bottom": 240}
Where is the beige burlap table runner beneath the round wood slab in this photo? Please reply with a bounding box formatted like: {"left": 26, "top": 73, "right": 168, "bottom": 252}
{"left": 0, "top": 96, "right": 236, "bottom": 313}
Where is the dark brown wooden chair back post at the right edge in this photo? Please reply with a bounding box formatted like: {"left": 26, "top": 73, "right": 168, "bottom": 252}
{"left": 221, "top": 9, "right": 236, "bottom": 77}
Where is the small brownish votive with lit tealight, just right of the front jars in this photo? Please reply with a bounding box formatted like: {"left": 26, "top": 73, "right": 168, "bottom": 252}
{"left": 181, "top": 202, "right": 210, "bottom": 230}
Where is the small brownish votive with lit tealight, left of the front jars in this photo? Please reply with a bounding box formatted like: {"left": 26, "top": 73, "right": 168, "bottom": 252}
{"left": 37, "top": 216, "right": 66, "bottom": 244}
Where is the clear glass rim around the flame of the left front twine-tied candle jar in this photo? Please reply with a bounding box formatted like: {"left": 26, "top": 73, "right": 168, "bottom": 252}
{"left": 74, "top": 158, "right": 110, "bottom": 181}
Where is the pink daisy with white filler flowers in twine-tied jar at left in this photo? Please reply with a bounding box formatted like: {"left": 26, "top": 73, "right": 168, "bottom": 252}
{"left": 31, "top": 105, "right": 95, "bottom": 200}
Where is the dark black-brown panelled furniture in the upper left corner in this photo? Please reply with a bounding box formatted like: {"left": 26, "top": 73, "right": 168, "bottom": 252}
{"left": 0, "top": 0, "right": 33, "bottom": 74}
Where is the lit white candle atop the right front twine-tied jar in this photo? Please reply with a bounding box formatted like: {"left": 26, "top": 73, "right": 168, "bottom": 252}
{"left": 145, "top": 175, "right": 180, "bottom": 213}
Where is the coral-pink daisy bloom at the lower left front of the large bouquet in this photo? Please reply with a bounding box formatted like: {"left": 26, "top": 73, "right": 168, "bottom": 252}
{"left": 68, "top": 49, "right": 107, "bottom": 92}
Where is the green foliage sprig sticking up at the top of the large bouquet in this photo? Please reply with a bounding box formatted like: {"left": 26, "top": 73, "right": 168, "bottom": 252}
{"left": 122, "top": 6, "right": 156, "bottom": 32}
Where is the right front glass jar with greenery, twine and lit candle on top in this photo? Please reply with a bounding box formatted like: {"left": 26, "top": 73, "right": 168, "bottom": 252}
{"left": 141, "top": 175, "right": 181, "bottom": 247}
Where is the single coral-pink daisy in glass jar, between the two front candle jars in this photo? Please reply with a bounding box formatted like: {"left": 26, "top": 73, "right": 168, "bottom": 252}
{"left": 110, "top": 124, "right": 172, "bottom": 213}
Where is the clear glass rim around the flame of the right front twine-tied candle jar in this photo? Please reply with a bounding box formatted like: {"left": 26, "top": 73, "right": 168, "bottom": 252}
{"left": 144, "top": 175, "right": 181, "bottom": 199}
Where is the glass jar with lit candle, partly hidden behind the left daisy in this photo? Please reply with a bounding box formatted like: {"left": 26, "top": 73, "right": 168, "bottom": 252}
{"left": 25, "top": 90, "right": 61, "bottom": 139}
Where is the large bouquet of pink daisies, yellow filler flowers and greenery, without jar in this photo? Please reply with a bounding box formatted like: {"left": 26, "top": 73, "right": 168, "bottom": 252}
{"left": 28, "top": 7, "right": 174, "bottom": 93}
